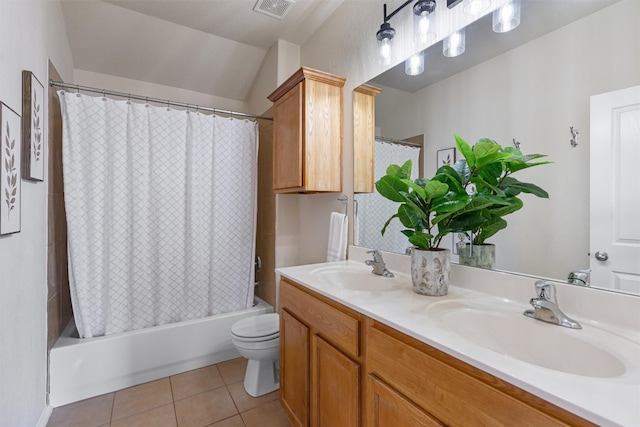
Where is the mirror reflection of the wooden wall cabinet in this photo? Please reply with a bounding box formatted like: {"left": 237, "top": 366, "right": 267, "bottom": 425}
{"left": 353, "top": 84, "right": 382, "bottom": 193}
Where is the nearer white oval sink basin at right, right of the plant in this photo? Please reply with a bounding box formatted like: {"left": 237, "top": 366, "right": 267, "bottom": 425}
{"left": 427, "top": 300, "right": 638, "bottom": 378}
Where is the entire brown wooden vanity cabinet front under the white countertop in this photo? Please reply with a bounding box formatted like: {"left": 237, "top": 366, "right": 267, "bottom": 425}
{"left": 280, "top": 278, "right": 594, "bottom": 427}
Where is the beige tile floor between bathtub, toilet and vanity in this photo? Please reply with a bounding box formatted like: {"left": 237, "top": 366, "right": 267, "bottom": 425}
{"left": 47, "top": 358, "right": 290, "bottom": 427}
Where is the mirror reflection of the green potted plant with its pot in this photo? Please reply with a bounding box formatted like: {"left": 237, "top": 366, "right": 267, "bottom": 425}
{"left": 448, "top": 135, "right": 550, "bottom": 269}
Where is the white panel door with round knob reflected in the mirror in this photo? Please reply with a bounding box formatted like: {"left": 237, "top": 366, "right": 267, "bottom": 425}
{"left": 590, "top": 86, "right": 640, "bottom": 293}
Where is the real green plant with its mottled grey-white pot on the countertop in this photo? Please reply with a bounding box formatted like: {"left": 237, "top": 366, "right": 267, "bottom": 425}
{"left": 376, "top": 160, "right": 472, "bottom": 296}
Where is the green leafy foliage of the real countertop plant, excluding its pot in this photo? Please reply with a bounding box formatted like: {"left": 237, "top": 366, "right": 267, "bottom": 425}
{"left": 376, "top": 160, "right": 472, "bottom": 250}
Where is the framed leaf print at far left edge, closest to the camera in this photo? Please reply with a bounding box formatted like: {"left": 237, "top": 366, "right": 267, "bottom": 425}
{"left": 0, "top": 102, "right": 22, "bottom": 234}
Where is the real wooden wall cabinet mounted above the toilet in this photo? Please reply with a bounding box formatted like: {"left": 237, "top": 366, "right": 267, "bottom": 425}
{"left": 268, "top": 67, "right": 345, "bottom": 193}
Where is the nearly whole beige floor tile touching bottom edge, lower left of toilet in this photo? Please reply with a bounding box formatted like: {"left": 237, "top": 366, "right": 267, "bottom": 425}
{"left": 175, "top": 387, "right": 238, "bottom": 427}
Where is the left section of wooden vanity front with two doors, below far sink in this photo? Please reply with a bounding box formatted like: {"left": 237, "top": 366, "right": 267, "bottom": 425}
{"left": 280, "top": 279, "right": 363, "bottom": 427}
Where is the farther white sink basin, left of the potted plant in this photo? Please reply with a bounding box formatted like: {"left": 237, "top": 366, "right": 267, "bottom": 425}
{"left": 309, "top": 265, "right": 411, "bottom": 292}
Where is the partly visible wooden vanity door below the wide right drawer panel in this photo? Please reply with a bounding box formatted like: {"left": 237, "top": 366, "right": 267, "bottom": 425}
{"left": 367, "top": 375, "right": 444, "bottom": 427}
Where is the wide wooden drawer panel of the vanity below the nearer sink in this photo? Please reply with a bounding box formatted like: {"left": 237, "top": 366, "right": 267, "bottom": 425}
{"left": 365, "top": 322, "right": 590, "bottom": 426}
